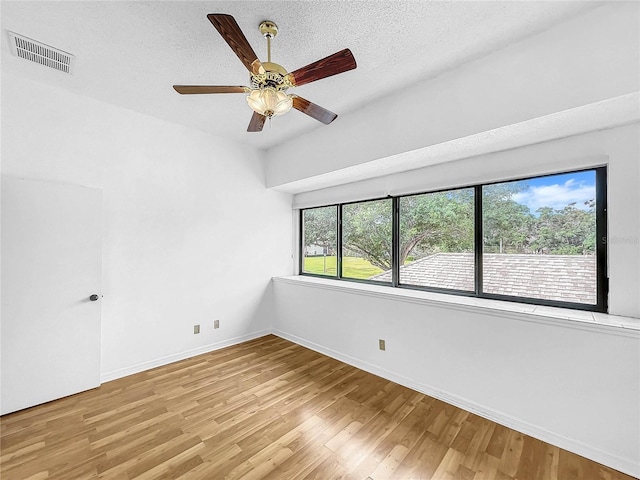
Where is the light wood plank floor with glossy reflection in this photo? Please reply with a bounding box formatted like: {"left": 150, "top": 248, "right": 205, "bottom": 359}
{"left": 0, "top": 336, "right": 631, "bottom": 480}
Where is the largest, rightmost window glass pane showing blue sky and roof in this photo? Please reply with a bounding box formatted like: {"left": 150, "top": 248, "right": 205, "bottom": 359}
{"left": 482, "top": 170, "right": 597, "bottom": 304}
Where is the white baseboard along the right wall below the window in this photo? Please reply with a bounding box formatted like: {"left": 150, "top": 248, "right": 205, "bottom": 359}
{"left": 271, "top": 329, "right": 640, "bottom": 478}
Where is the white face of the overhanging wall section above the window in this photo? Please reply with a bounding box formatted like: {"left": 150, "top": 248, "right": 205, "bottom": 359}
{"left": 267, "top": 2, "right": 640, "bottom": 187}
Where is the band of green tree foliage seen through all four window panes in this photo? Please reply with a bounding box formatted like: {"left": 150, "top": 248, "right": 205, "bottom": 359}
{"left": 304, "top": 181, "right": 596, "bottom": 270}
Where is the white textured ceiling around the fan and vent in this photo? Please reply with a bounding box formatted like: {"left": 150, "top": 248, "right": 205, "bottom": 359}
{"left": 2, "top": 0, "right": 602, "bottom": 149}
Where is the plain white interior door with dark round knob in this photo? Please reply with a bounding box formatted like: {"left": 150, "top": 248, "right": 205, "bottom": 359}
{"left": 0, "top": 176, "right": 102, "bottom": 414}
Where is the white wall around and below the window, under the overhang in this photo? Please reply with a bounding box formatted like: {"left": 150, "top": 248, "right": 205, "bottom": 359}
{"left": 274, "top": 124, "right": 640, "bottom": 475}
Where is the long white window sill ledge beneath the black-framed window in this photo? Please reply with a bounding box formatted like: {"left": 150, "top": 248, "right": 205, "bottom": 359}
{"left": 273, "top": 275, "right": 640, "bottom": 337}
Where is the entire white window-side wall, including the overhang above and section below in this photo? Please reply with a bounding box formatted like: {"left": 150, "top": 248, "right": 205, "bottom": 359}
{"left": 267, "top": 2, "right": 640, "bottom": 476}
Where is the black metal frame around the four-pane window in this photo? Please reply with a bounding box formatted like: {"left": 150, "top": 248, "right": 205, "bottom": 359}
{"left": 298, "top": 166, "right": 609, "bottom": 313}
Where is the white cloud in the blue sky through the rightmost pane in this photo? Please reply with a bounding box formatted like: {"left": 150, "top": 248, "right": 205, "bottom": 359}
{"left": 513, "top": 179, "right": 596, "bottom": 213}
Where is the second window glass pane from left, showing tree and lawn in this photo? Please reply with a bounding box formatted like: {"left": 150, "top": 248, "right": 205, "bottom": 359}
{"left": 342, "top": 199, "right": 392, "bottom": 282}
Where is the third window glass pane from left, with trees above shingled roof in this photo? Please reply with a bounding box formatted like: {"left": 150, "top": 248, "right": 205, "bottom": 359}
{"left": 400, "top": 188, "right": 475, "bottom": 291}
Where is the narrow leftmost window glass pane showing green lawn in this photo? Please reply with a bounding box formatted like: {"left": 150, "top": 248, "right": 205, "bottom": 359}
{"left": 302, "top": 206, "right": 338, "bottom": 277}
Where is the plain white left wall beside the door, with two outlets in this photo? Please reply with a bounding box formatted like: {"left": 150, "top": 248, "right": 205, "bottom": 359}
{"left": 2, "top": 71, "right": 292, "bottom": 381}
